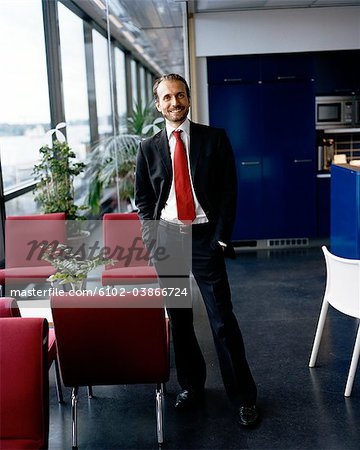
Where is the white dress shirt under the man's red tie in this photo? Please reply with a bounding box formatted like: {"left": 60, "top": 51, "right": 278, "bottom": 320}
{"left": 160, "top": 119, "right": 208, "bottom": 224}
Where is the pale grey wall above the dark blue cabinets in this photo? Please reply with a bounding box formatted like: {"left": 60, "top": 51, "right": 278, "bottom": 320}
{"left": 194, "top": 7, "right": 360, "bottom": 123}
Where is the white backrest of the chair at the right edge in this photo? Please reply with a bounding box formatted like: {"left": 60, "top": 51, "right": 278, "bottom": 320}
{"left": 322, "top": 246, "right": 360, "bottom": 319}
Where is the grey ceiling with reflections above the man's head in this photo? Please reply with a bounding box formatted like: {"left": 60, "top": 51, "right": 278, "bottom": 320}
{"left": 109, "top": 0, "right": 360, "bottom": 74}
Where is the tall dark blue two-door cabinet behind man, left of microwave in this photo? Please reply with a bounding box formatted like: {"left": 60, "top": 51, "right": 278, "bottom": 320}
{"left": 208, "top": 57, "right": 316, "bottom": 240}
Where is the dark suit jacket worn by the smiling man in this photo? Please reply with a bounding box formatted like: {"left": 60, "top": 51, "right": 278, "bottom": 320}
{"left": 135, "top": 122, "right": 237, "bottom": 243}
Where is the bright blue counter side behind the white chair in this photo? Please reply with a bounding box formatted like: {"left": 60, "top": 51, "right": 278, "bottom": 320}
{"left": 330, "top": 165, "right": 360, "bottom": 259}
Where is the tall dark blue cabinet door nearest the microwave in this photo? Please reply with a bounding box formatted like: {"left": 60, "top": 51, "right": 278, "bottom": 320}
{"left": 262, "top": 81, "right": 316, "bottom": 238}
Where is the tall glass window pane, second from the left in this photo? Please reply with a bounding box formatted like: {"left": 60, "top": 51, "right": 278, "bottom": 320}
{"left": 59, "top": 3, "right": 90, "bottom": 160}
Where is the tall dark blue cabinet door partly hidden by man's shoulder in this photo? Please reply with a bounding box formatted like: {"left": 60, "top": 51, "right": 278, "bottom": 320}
{"left": 209, "top": 83, "right": 263, "bottom": 240}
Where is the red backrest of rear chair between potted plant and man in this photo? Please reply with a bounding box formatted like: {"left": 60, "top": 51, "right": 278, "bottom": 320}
{"left": 103, "top": 213, "right": 148, "bottom": 269}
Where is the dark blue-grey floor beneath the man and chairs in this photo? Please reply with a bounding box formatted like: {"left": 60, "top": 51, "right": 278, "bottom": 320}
{"left": 50, "top": 248, "right": 360, "bottom": 450}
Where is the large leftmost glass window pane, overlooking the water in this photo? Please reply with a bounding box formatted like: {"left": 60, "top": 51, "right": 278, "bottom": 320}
{"left": 0, "top": 0, "right": 50, "bottom": 188}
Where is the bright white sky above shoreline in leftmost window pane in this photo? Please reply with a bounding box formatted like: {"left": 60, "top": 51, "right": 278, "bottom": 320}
{"left": 0, "top": 0, "right": 49, "bottom": 124}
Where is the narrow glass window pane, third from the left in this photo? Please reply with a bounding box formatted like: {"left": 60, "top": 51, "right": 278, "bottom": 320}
{"left": 93, "top": 30, "right": 113, "bottom": 138}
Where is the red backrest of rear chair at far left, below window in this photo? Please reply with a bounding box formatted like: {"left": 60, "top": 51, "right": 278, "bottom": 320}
{"left": 5, "top": 213, "right": 66, "bottom": 268}
